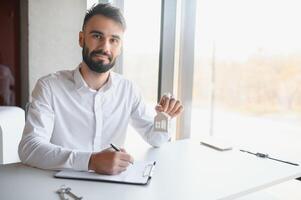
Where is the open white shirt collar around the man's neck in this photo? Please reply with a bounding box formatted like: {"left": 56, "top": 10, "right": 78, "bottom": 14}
{"left": 74, "top": 64, "right": 116, "bottom": 92}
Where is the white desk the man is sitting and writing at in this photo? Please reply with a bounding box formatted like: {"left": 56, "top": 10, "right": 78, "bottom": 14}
{"left": 0, "top": 140, "right": 301, "bottom": 200}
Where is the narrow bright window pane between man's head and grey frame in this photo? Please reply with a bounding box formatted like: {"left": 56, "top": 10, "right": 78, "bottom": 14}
{"left": 123, "top": 0, "right": 161, "bottom": 107}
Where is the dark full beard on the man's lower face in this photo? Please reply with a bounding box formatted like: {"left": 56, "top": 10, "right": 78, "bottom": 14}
{"left": 82, "top": 45, "right": 115, "bottom": 73}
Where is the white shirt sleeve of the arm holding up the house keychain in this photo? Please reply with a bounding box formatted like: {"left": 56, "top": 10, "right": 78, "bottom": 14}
{"left": 130, "top": 85, "right": 170, "bottom": 147}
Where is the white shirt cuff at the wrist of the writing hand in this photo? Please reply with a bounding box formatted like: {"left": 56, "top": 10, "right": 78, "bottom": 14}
{"left": 73, "top": 151, "right": 92, "bottom": 171}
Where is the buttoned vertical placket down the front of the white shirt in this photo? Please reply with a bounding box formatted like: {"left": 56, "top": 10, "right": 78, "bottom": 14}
{"left": 93, "top": 93, "right": 103, "bottom": 152}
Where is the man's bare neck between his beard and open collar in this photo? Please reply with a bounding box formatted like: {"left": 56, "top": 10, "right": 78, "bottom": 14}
{"left": 80, "top": 62, "right": 110, "bottom": 90}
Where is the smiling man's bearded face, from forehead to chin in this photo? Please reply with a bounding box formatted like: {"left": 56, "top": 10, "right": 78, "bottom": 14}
{"left": 79, "top": 15, "right": 123, "bottom": 73}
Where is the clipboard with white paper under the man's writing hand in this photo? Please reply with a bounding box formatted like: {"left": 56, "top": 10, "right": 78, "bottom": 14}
{"left": 54, "top": 161, "right": 156, "bottom": 185}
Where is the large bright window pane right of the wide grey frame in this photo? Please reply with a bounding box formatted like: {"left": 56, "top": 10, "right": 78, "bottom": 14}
{"left": 192, "top": 0, "right": 301, "bottom": 148}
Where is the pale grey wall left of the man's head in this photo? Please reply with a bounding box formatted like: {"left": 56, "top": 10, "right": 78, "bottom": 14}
{"left": 28, "top": 0, "right": 86, "bottom": 94}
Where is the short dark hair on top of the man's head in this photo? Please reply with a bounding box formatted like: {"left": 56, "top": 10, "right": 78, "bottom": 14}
{"left": 82, "top": 3, "right": 126, "bottom": 30}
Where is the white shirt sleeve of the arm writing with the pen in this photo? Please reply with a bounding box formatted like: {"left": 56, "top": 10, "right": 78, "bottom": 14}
{"left": 18, "top": 80, "right": 91, "bottom": 171}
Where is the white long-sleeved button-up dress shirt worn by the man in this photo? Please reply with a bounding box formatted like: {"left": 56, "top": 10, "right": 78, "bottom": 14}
{"left": 19, "top": 66, "right": 170, "bottom": 171}
